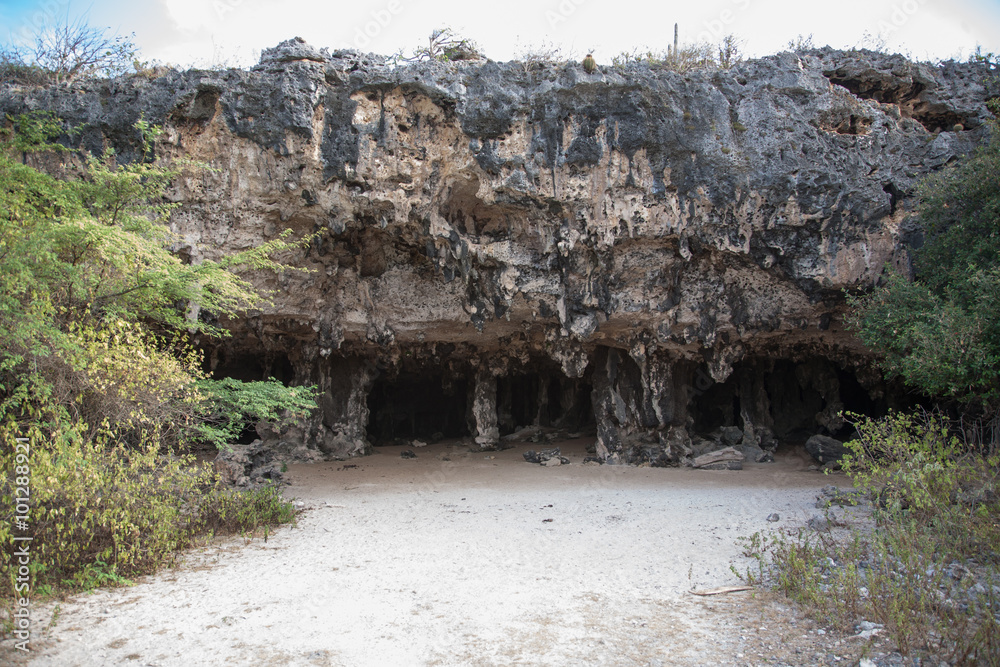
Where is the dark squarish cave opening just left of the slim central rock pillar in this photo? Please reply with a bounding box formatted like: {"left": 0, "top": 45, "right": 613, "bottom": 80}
{"left": 368, "top": 372, "right": 470, "bottom": 445}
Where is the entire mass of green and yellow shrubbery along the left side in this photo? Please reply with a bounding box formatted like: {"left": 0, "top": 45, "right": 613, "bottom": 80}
{"left": 0, "top": 109, "right": 315, "bottom": 628}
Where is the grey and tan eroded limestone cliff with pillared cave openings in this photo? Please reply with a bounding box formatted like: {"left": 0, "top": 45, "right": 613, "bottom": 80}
{"left": 0, "top": 40, "right": 988, "bottom": 463}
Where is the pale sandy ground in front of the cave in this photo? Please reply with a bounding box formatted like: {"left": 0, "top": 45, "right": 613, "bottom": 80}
{"left": 0, "top": 441, "right": 880, "bottom": 667}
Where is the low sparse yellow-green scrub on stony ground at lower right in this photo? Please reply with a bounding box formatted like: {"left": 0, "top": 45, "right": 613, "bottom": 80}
{"left": 742, "top": 414, "right": 1000, "bottom": 665}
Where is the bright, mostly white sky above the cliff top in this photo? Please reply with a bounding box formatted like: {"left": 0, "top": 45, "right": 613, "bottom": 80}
{"left": 0, "top": 0, "right": 1000, "bottom": 66}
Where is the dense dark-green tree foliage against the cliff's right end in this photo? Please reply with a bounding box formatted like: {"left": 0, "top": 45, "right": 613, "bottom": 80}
{"left": 850, "top": 107, "right": 1000, "bottom": 409}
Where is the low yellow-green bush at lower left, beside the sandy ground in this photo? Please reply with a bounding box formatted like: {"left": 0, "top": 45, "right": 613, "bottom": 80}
{"left": 0, "top": 422, "right": 294, "bottom": 600}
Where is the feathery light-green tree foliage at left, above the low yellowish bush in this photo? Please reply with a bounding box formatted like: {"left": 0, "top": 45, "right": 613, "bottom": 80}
{"left": 0, "top": 115, "right": 314, "bottom": 445}
